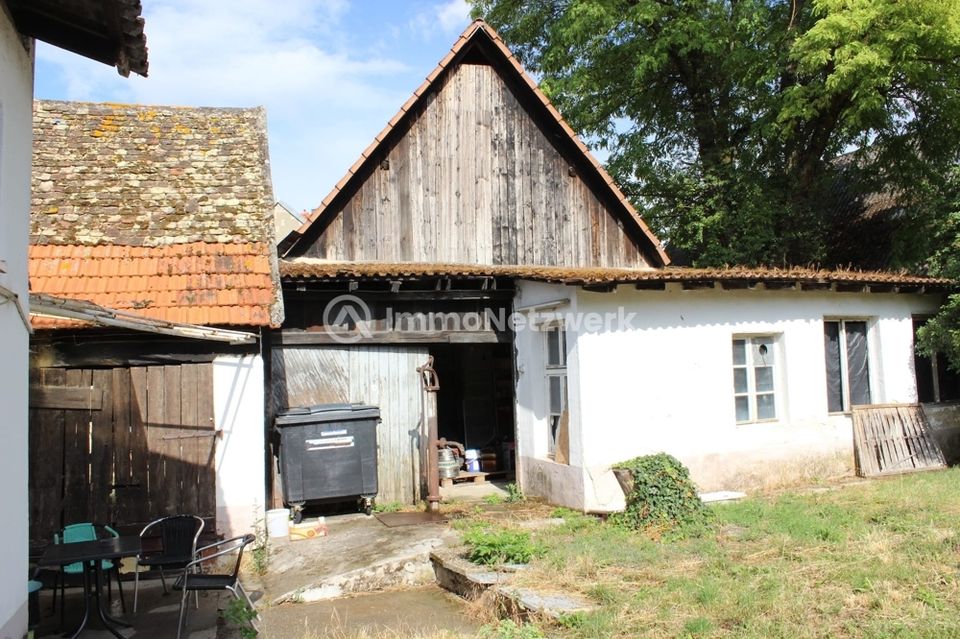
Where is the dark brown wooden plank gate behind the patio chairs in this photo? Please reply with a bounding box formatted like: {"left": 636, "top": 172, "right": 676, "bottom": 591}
{"left": 29, "top": 363, "right": 216, "bottom": 541}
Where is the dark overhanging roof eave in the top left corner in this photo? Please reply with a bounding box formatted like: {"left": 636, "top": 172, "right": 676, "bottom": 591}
{"left": 6, "top": 0, "right": 147, "bottom": 76}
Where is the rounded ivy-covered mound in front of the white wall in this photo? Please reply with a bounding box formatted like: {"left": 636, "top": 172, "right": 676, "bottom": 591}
{"left": 612, "top": 453, "right": 710, "bottom": 534}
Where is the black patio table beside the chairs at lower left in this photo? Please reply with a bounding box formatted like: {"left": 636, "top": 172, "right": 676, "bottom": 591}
{"left": 38, "top": 536, "right": 140, "bottom": 639}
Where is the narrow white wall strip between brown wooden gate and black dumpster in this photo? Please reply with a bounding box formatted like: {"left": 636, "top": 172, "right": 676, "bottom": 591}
{"left": 213, "top": 355, "right": 266, "bottom": 537}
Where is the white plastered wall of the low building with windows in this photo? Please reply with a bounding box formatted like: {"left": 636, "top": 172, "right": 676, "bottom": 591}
{"left": 517, "top": 283, "right": 939, "bottom": 511}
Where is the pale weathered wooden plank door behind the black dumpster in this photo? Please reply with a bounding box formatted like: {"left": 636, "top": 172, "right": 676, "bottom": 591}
{"left": 272, "top": 346, "right": 427, "bottom": 504}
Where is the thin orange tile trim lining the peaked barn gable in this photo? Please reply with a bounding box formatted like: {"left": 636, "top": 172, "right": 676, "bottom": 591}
{"left": 279, "top": 19, "right": 670, "bottom": 266}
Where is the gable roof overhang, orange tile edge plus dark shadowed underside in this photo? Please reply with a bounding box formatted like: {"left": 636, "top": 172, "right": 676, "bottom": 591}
{"left": 280, "top": 20, "right": 670, "bottom": 266}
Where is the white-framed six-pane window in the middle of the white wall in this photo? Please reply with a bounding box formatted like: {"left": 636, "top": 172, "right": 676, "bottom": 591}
{"left": 733, "top": 335, "right": 777, "bottom": 423}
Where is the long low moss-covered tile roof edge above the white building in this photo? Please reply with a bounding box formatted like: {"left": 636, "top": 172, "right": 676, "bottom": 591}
{"left": 280, "top": 258, "right": 953, "bottom": 291}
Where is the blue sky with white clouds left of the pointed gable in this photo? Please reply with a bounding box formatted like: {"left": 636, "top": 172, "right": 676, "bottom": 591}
{"left": 37, "top": 0, "right": 416, "bottom": 209}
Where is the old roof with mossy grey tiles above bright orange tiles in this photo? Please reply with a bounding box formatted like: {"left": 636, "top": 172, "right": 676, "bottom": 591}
{"left": 30, "top": 101, "right": 283, "bottom": 328}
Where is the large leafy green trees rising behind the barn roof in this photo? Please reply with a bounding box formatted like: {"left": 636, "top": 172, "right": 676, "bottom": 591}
{"left": 471, "top": 0, "right": 960, "bottom": 268}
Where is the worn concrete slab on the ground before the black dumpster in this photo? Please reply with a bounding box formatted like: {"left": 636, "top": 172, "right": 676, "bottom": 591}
{"left": 262, "top": 514, "right": 457, "bottom": 604}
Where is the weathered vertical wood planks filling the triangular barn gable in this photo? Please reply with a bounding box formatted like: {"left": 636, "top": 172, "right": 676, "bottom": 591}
{"left": 305, "top": 64, "right": 647, "bottom": 267}
